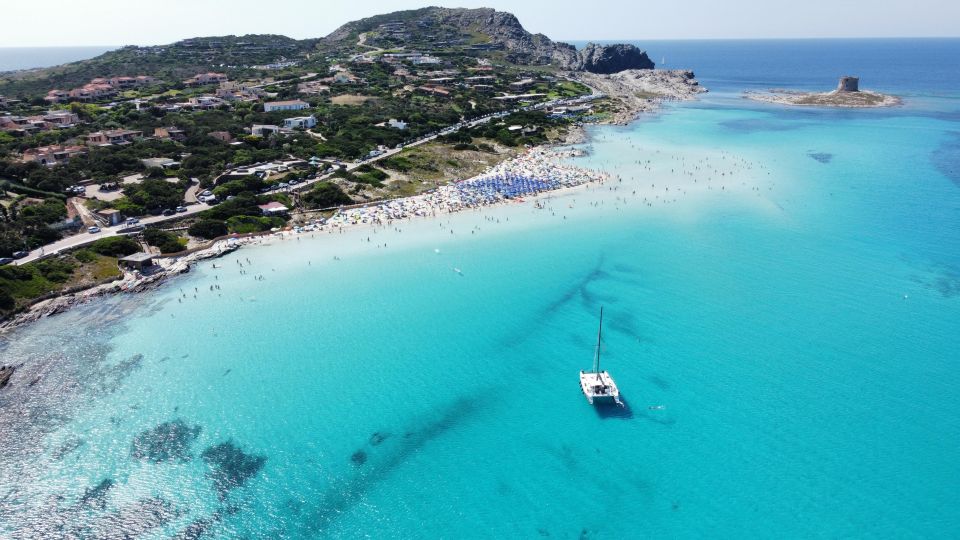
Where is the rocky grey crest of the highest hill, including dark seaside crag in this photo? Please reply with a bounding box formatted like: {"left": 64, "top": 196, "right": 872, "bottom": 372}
{"left": 324, "top": 7, "right": 654, "bottom": 73}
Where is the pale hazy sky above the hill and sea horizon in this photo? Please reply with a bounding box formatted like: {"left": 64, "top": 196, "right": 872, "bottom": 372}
{"left": 0, "top": 0, "right": 960, "bottom": 47}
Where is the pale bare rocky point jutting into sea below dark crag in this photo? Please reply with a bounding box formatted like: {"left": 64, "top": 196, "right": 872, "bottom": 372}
{"left": 567, "top": 69, "right": 708, "bottom": 125}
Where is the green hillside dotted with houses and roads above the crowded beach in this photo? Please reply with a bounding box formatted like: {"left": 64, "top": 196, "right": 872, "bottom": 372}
{"left": 0, "top": 8, "right": 680, "bottom": 312}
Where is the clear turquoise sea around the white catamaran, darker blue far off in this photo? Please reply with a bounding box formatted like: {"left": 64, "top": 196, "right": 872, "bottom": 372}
{"left": 0, "top": 40, "right": 960, "bottom": 538}
